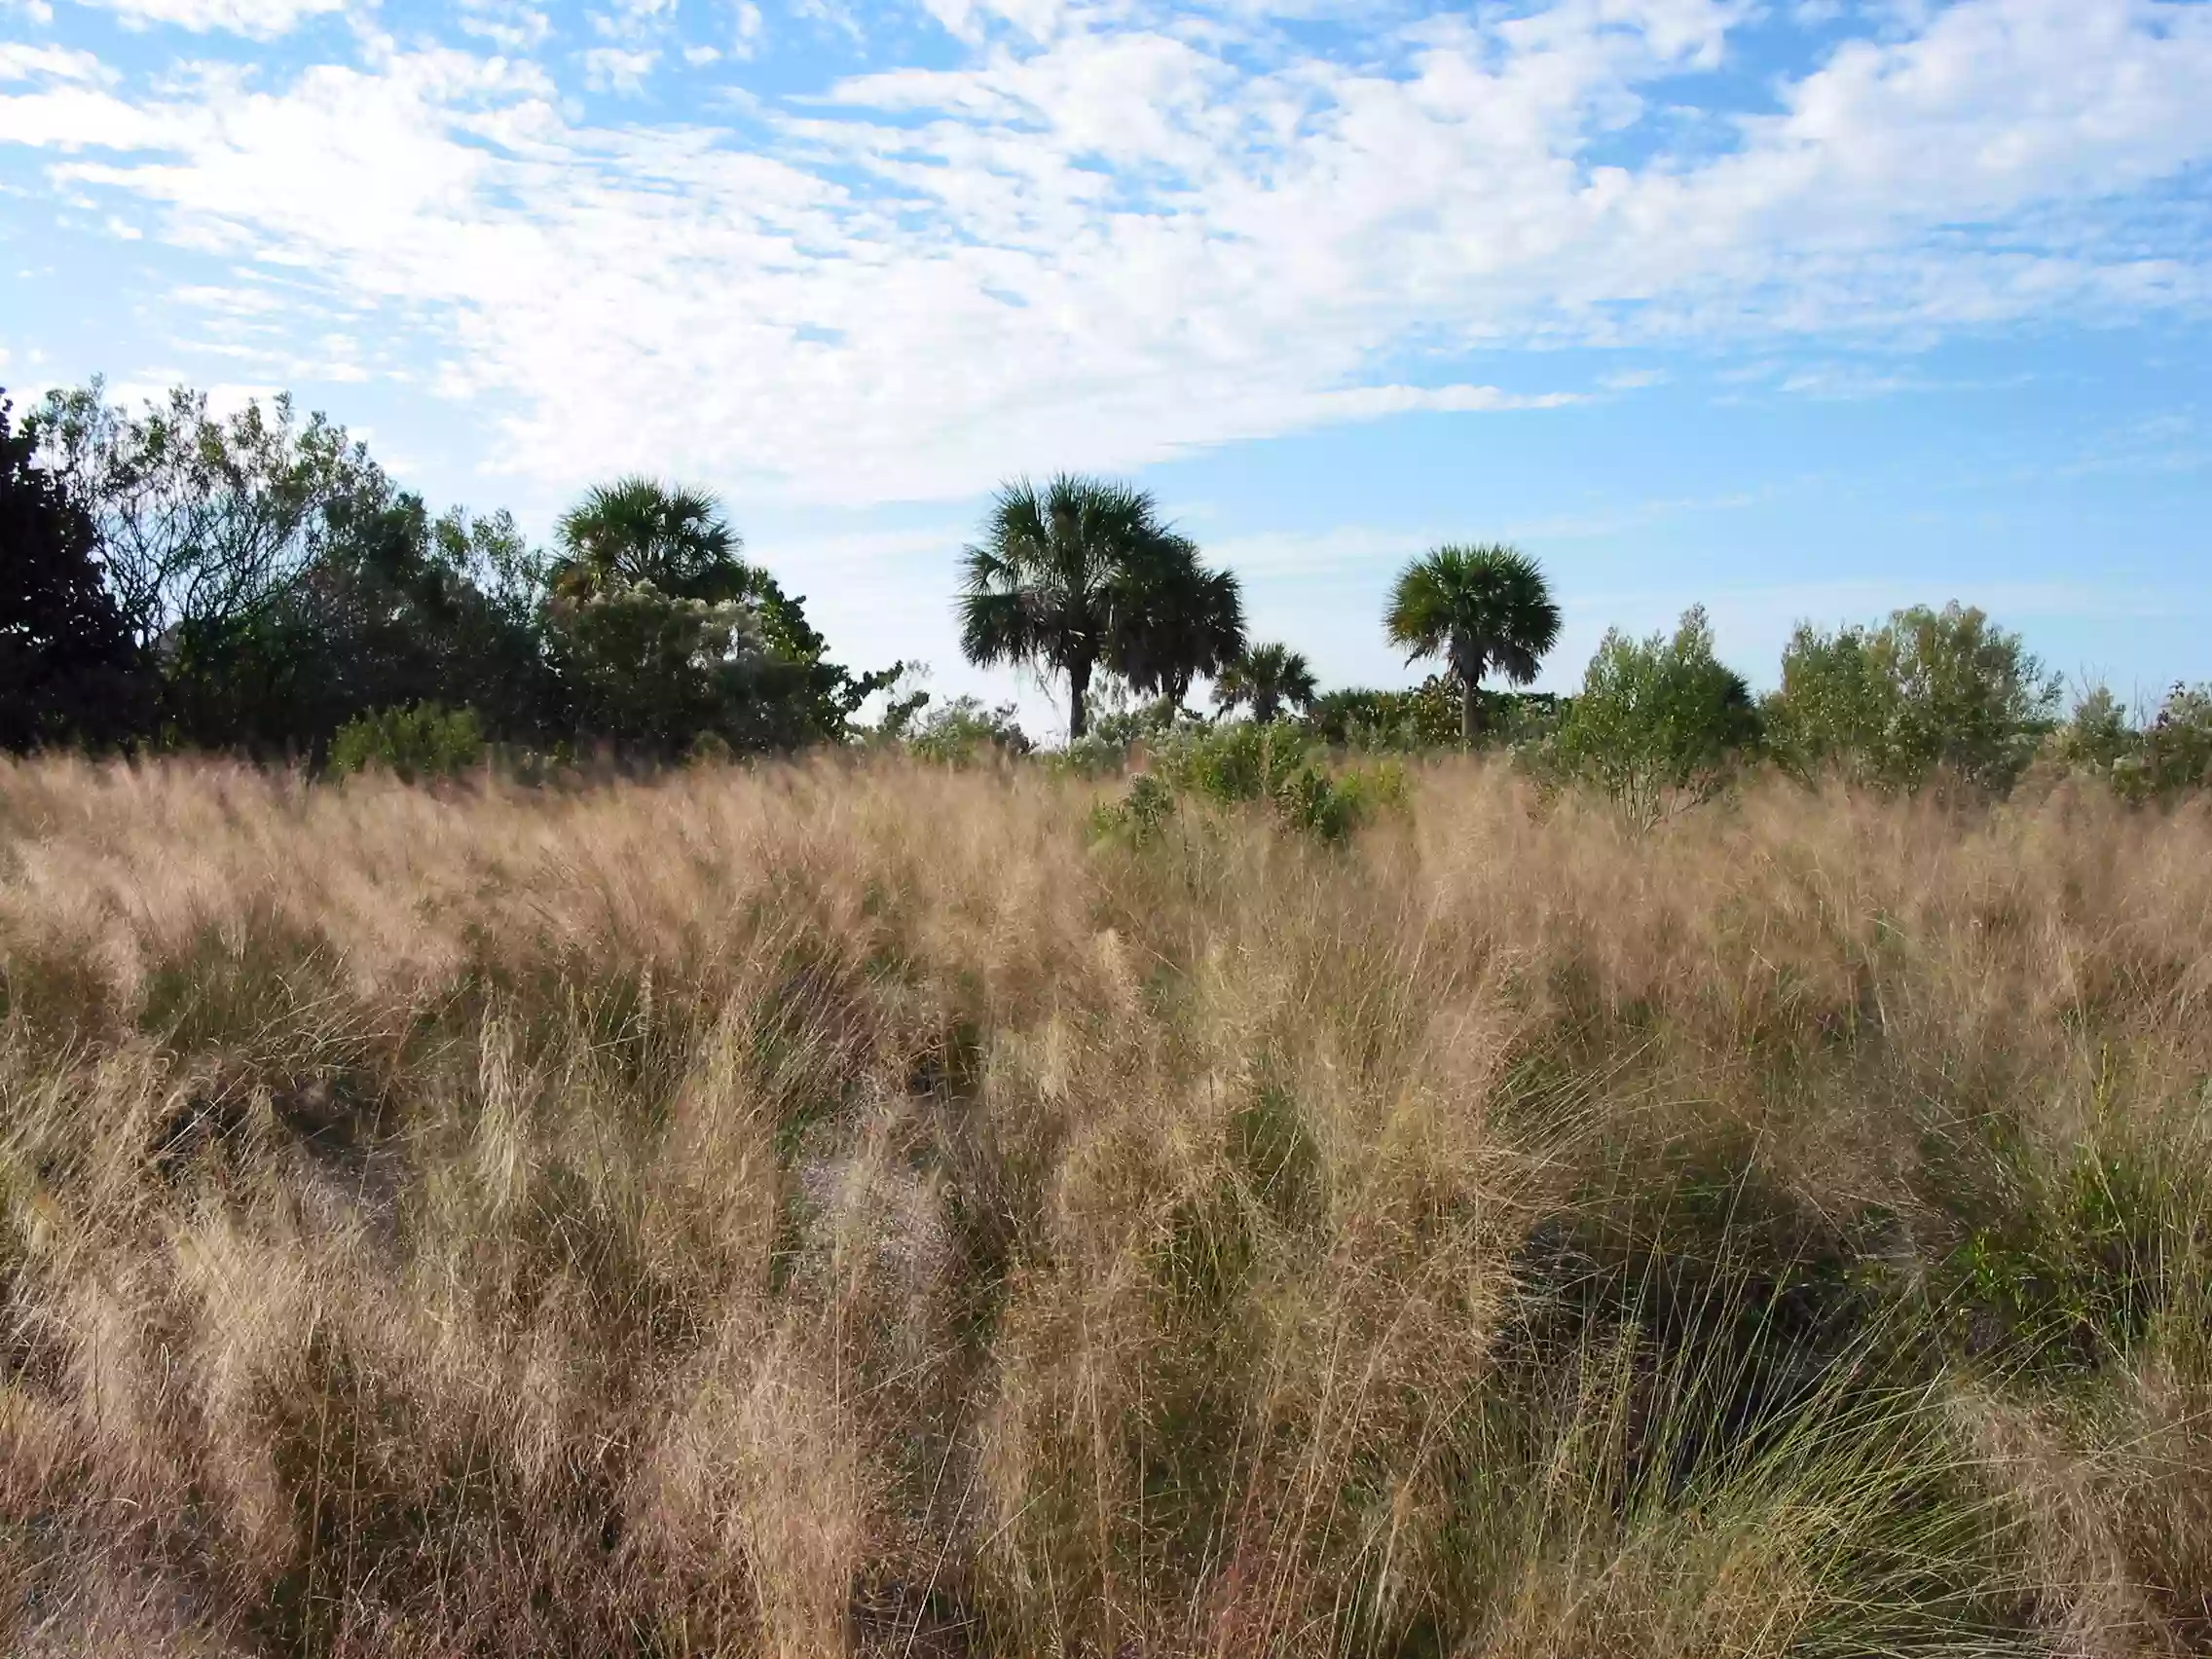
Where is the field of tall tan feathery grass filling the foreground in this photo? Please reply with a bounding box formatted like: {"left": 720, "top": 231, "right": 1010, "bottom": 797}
{"left": 0, "top": 763, "right": 2212, "bottom": 1659}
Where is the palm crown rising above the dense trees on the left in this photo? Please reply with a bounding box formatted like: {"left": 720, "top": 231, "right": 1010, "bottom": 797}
{"left": 553, "top": 475, "right": 755, "bottom": 604}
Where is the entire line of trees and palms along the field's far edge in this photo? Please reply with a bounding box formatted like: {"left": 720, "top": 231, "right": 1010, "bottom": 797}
{"left": 0, "top": 381, "right": 2212, "bottom": 819}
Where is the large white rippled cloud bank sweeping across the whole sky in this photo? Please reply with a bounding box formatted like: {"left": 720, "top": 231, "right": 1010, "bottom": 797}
{"left": 0, "top": 0, "right": 2212, "bottom": 502}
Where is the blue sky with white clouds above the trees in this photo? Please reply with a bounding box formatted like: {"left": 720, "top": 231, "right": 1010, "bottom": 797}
{"left": 0, "top": 0, "right": 2212, "bottom": 732}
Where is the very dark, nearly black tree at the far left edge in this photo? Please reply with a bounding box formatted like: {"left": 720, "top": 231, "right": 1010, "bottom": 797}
{"left": 0, "top": 396, "right": 144, "bottom": 750}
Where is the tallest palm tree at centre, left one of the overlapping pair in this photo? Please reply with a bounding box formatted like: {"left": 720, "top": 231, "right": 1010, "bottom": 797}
{"left": 958, "top": 473, "right": 1168, "bottom": 739}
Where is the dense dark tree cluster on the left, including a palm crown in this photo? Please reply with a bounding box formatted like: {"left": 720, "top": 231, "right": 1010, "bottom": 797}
{"left": 0, "top": 383, "right": 898, "bottom": 761}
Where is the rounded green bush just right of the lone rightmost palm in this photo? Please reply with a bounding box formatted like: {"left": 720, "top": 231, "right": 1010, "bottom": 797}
{"left": 1553, "top": 607, "right": 1758, "bottom": 825}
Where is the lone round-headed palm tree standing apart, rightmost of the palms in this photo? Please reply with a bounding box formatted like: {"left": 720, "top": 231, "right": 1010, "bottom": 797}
{"left": 1382, "top": 546, "right": 1560, "bottom": 743}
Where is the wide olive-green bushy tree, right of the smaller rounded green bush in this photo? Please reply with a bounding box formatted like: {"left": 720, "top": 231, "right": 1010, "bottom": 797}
{"left": 1765, "top": 602, "right": 2059, "bottom": 794}
